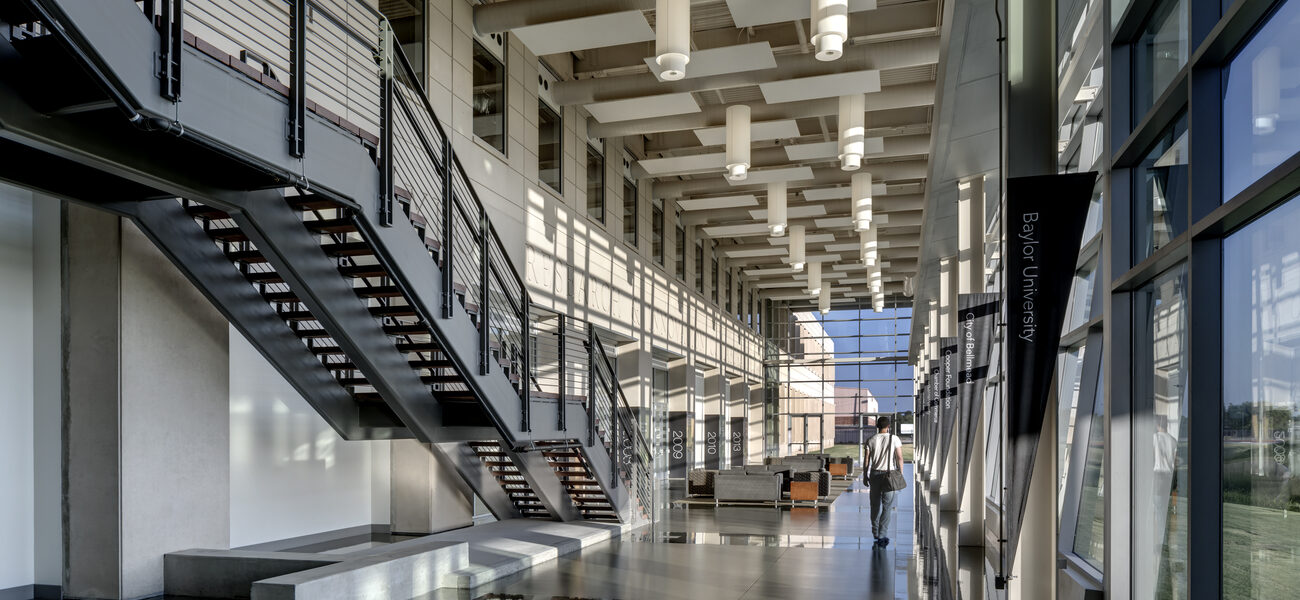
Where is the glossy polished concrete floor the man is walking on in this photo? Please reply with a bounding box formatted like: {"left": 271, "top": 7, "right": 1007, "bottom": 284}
{"left": 426, "top": 469, "right": 940, "bottom": 600}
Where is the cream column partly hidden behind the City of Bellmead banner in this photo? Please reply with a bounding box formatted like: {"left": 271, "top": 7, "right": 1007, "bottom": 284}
{"left": 957, "top": 177, "right": 985, "bottom": 547}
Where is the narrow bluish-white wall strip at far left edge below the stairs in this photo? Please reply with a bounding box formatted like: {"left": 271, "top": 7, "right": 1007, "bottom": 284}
{"left": 0, "top": 184, "right": 35, "bottom": 590}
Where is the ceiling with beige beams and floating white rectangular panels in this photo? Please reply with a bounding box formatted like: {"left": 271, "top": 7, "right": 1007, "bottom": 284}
{"left": 476, "top": 0, "right": 941, "bottom": 303}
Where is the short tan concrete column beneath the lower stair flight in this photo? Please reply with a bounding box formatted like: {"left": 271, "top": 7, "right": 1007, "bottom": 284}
{"left": 389, "top": 439, "right": 475, "bottom": 535}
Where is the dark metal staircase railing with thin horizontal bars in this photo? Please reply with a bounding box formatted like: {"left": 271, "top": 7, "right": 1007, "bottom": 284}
{"left": 152, "top": 0, "right": 654, "bottom": 510}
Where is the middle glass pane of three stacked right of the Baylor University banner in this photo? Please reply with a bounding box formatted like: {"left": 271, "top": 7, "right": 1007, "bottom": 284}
{"left": 1132, "top": 114, "right": 1188, "bottom": 265}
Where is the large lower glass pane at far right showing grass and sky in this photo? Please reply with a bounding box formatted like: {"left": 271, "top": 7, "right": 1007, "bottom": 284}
{"left": 1223, "top": 194, "right": 1300, "bottom": 600}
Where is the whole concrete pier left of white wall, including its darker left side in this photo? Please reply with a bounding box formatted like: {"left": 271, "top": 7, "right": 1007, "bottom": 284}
{"left": 62, "top": 205, "right": 230, "bottom": 599}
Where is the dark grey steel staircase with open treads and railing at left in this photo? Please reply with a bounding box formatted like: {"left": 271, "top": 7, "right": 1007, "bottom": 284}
{"left": 0, "top": 0, "right": 653, "bottom": 523}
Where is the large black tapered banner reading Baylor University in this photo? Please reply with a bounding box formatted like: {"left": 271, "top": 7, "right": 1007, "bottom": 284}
{"left": 1004, "top": 173, "right": 1097, "bottom": 565}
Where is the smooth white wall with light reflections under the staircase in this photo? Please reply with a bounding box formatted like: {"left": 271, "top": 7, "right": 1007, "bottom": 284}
{"left": 230, "top": 329, "right": 389, "bottom": 548}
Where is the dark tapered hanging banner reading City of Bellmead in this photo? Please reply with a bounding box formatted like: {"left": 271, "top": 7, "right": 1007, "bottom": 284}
{"left": 957, "top": 294, "right": 998, "bottom": 495}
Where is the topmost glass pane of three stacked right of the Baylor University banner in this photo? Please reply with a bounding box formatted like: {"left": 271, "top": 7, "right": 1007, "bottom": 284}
{"left": 1134, "top": 0, "right": 1188, "bottom": 122}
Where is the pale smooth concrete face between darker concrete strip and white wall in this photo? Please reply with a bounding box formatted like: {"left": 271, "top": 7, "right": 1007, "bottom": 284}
{"left": 120, "top": 222, "right": 230, "bottom": 597}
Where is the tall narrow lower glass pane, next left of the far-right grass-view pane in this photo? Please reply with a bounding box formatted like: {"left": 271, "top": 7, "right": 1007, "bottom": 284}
{"left": 1132, "top": 264, "right": 1191, "bottom": 600}
